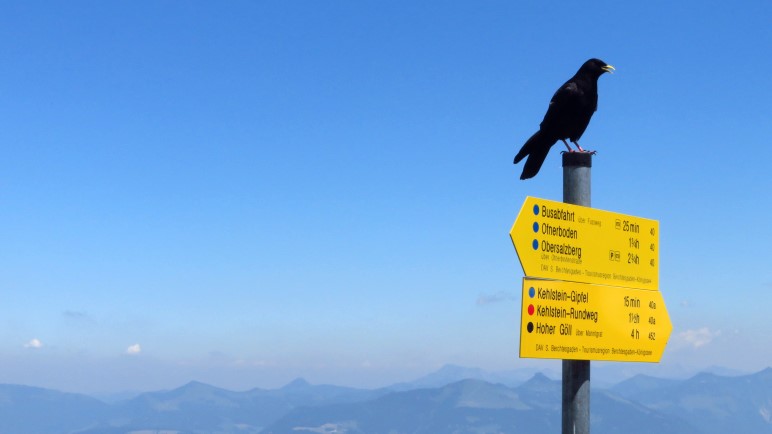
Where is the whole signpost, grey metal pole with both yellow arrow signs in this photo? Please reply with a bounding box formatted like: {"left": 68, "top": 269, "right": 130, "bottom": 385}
{"left": 509, "top": 152, "right": 673, "bottom": 434}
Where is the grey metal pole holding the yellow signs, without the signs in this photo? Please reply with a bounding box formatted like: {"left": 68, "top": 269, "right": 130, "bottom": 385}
{"left": 562, "top": 152, "right": 592, "bottom": 434}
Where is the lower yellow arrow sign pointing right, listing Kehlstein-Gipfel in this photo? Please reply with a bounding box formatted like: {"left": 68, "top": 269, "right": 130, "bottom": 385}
{"left": 520, "top": 278, "right": 673, "bottom": 362}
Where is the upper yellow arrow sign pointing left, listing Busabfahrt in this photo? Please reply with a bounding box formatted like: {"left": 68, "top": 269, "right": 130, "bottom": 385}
{"left": 509, "top": 196, "right": 659, "bottom": 291}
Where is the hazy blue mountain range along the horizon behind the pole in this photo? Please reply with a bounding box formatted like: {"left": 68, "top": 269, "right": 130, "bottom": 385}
{"left": 0, "top": 366, "right": 772, "bottom": 434}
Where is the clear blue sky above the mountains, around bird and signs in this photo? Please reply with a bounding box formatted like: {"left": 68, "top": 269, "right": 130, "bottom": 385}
{"left": 0, "top": 1, "right": 772, "bottom": 392}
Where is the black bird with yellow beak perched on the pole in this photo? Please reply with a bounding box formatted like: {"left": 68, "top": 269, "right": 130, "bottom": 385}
{"left": 515, "top": 59, "right": 614, "bottom": 179}
